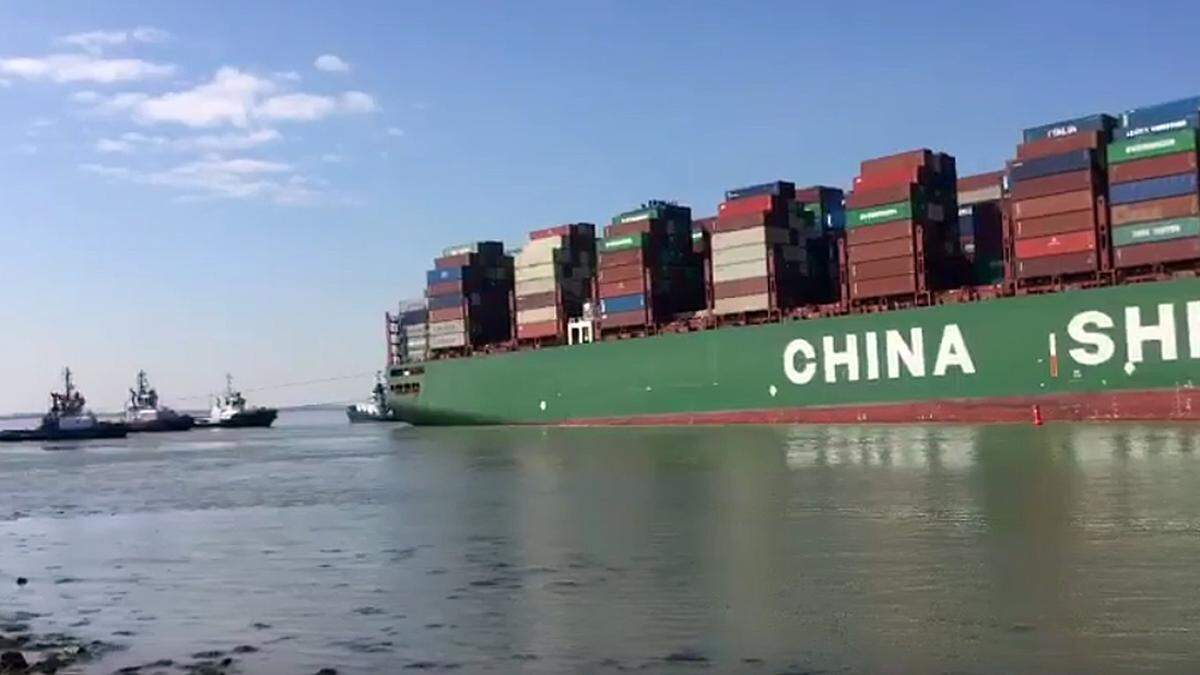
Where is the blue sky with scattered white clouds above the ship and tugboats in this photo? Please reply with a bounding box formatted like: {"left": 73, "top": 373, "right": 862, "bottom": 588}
{"left": 0, "top": 2, "right": 1200, "bottom": 411}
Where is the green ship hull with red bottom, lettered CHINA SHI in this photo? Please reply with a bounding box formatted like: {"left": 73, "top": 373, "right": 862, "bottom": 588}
{"left": 389, "top": 279, "right": 1200, "bottom": 425}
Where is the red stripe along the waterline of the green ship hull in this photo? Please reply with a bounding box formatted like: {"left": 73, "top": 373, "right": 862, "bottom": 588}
{"left": 549, "top": 388, "right": 1200, "bottom": 426}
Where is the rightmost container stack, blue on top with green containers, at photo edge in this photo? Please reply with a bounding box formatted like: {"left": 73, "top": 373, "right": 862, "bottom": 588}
{"left": 1108, "top": 98, "right": 1200, "bottom": 269}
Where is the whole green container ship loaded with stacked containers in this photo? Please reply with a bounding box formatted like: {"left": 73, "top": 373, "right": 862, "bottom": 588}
{"left": 386, "top": 97, "right": 1200, "bottom": 425}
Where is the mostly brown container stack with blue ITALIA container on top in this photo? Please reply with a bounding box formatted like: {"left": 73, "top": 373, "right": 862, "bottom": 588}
{"left": 1008, "top": 114, "right": 1116, "bottom": 285}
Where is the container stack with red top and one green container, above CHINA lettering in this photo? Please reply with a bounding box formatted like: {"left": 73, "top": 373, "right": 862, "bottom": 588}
{"left": 846, "top": 149, "right": 961, "bottom": 301}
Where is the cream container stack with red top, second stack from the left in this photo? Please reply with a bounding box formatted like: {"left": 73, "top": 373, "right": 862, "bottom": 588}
{"left": 514, "top": 222, "right": 596, "bottom": 344}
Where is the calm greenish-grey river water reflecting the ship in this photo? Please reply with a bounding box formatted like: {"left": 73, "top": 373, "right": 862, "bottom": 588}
{"left": 0, "top": 412, "right": 1200, "bottom": 674}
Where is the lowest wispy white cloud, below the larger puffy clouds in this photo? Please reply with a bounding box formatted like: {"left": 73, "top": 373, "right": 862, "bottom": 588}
{"left": 79, "top": 155, "right": 320, "bottom": 205}
